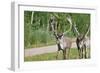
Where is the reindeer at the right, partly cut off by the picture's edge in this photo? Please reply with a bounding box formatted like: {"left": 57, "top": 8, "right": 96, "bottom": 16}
{"left": 69, "top": 17, "right": 89, "bottom": 58}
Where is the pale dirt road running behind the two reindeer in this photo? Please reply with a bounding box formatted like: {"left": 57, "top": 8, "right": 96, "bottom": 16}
{"left": 24, "top": 43, "right": 76, "bottom": 57}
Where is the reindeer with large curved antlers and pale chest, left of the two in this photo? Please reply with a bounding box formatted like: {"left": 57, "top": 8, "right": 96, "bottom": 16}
{"left": 49, "top": 16, "right": 72, "bottom": 59}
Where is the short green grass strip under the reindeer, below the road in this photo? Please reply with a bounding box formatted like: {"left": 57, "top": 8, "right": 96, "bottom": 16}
{"left": 24, "top": 48, "right": 90, "bottom": 62}
